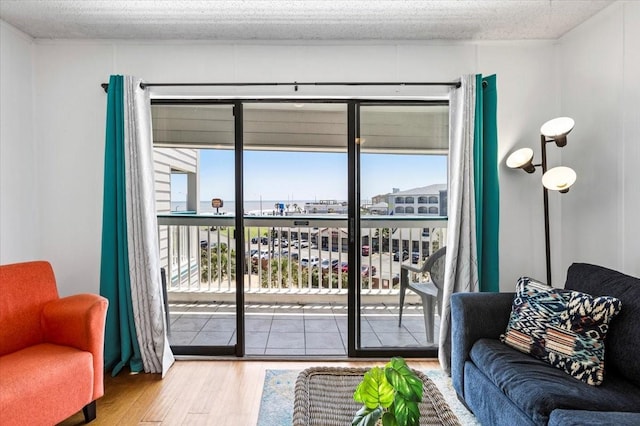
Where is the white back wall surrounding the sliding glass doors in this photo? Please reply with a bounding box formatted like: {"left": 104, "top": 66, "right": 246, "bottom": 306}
{"left": 31, "top": 41, "right": 557, "bottom": 293}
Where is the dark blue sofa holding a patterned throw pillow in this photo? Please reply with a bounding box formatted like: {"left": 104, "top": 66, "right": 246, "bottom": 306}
{"left": 451, "top": 263, "right": 640, "bottom": 426}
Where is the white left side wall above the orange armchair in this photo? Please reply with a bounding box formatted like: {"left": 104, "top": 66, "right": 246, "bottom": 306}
{"left": 0, "top": 21, "right": 41, "bottom": 264}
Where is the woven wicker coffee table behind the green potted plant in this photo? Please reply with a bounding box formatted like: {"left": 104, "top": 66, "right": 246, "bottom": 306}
{"left": 293, "top": 367, "right": 460, "bottom": 426}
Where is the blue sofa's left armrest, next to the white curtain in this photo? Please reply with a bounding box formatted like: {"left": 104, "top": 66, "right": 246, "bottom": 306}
{"left": 451, "top": 293, "right": 514, "bottom": 399}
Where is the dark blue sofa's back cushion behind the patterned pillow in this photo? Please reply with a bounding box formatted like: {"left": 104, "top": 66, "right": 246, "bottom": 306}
{"left": 565, "top": 263, "right": 640, "bottom": 386}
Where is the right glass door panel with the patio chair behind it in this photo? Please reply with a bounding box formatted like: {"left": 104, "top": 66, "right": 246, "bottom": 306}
{"left": 357, "top": 103, "right": 448, "bottom": 354}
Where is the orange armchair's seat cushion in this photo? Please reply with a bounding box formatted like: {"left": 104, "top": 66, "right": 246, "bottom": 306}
{"left": 0, "top": 343, "right": 93, "bottom": 425}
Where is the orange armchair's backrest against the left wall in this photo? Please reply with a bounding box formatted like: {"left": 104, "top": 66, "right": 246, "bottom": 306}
{"left": 0, "top": 261, "right": 58, "bottom": 356}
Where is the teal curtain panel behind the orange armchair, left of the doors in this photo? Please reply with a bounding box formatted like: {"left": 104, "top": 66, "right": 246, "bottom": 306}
{"left": 100, "top": 75, "right": 143, "bottom": 376}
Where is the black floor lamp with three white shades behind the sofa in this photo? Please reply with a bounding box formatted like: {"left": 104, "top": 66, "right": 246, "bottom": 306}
{"left": 507, "top": 117, "right": 576, "bottom": 285}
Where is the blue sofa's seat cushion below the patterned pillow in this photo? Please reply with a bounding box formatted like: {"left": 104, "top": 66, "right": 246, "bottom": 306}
{"left": 469, "top": 339, "right": 640, "bottom": 424}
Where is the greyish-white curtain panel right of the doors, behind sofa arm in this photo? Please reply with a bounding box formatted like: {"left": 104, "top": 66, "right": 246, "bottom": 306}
{"left": 438, "top": 75, "right": 478, "bottom": 373}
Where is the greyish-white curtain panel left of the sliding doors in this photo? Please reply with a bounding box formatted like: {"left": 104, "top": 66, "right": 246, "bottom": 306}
{"left": 123, "top": 76, "right": 174, "bottom": 377}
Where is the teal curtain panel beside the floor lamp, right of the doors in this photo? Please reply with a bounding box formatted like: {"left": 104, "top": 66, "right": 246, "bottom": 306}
{"left": 473, "top": 74, "right": 500, "bottom": 292}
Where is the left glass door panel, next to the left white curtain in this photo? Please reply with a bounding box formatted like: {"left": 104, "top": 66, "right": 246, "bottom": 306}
{"left": 151, "top": 100, "right": 237, "bottom": 355}
